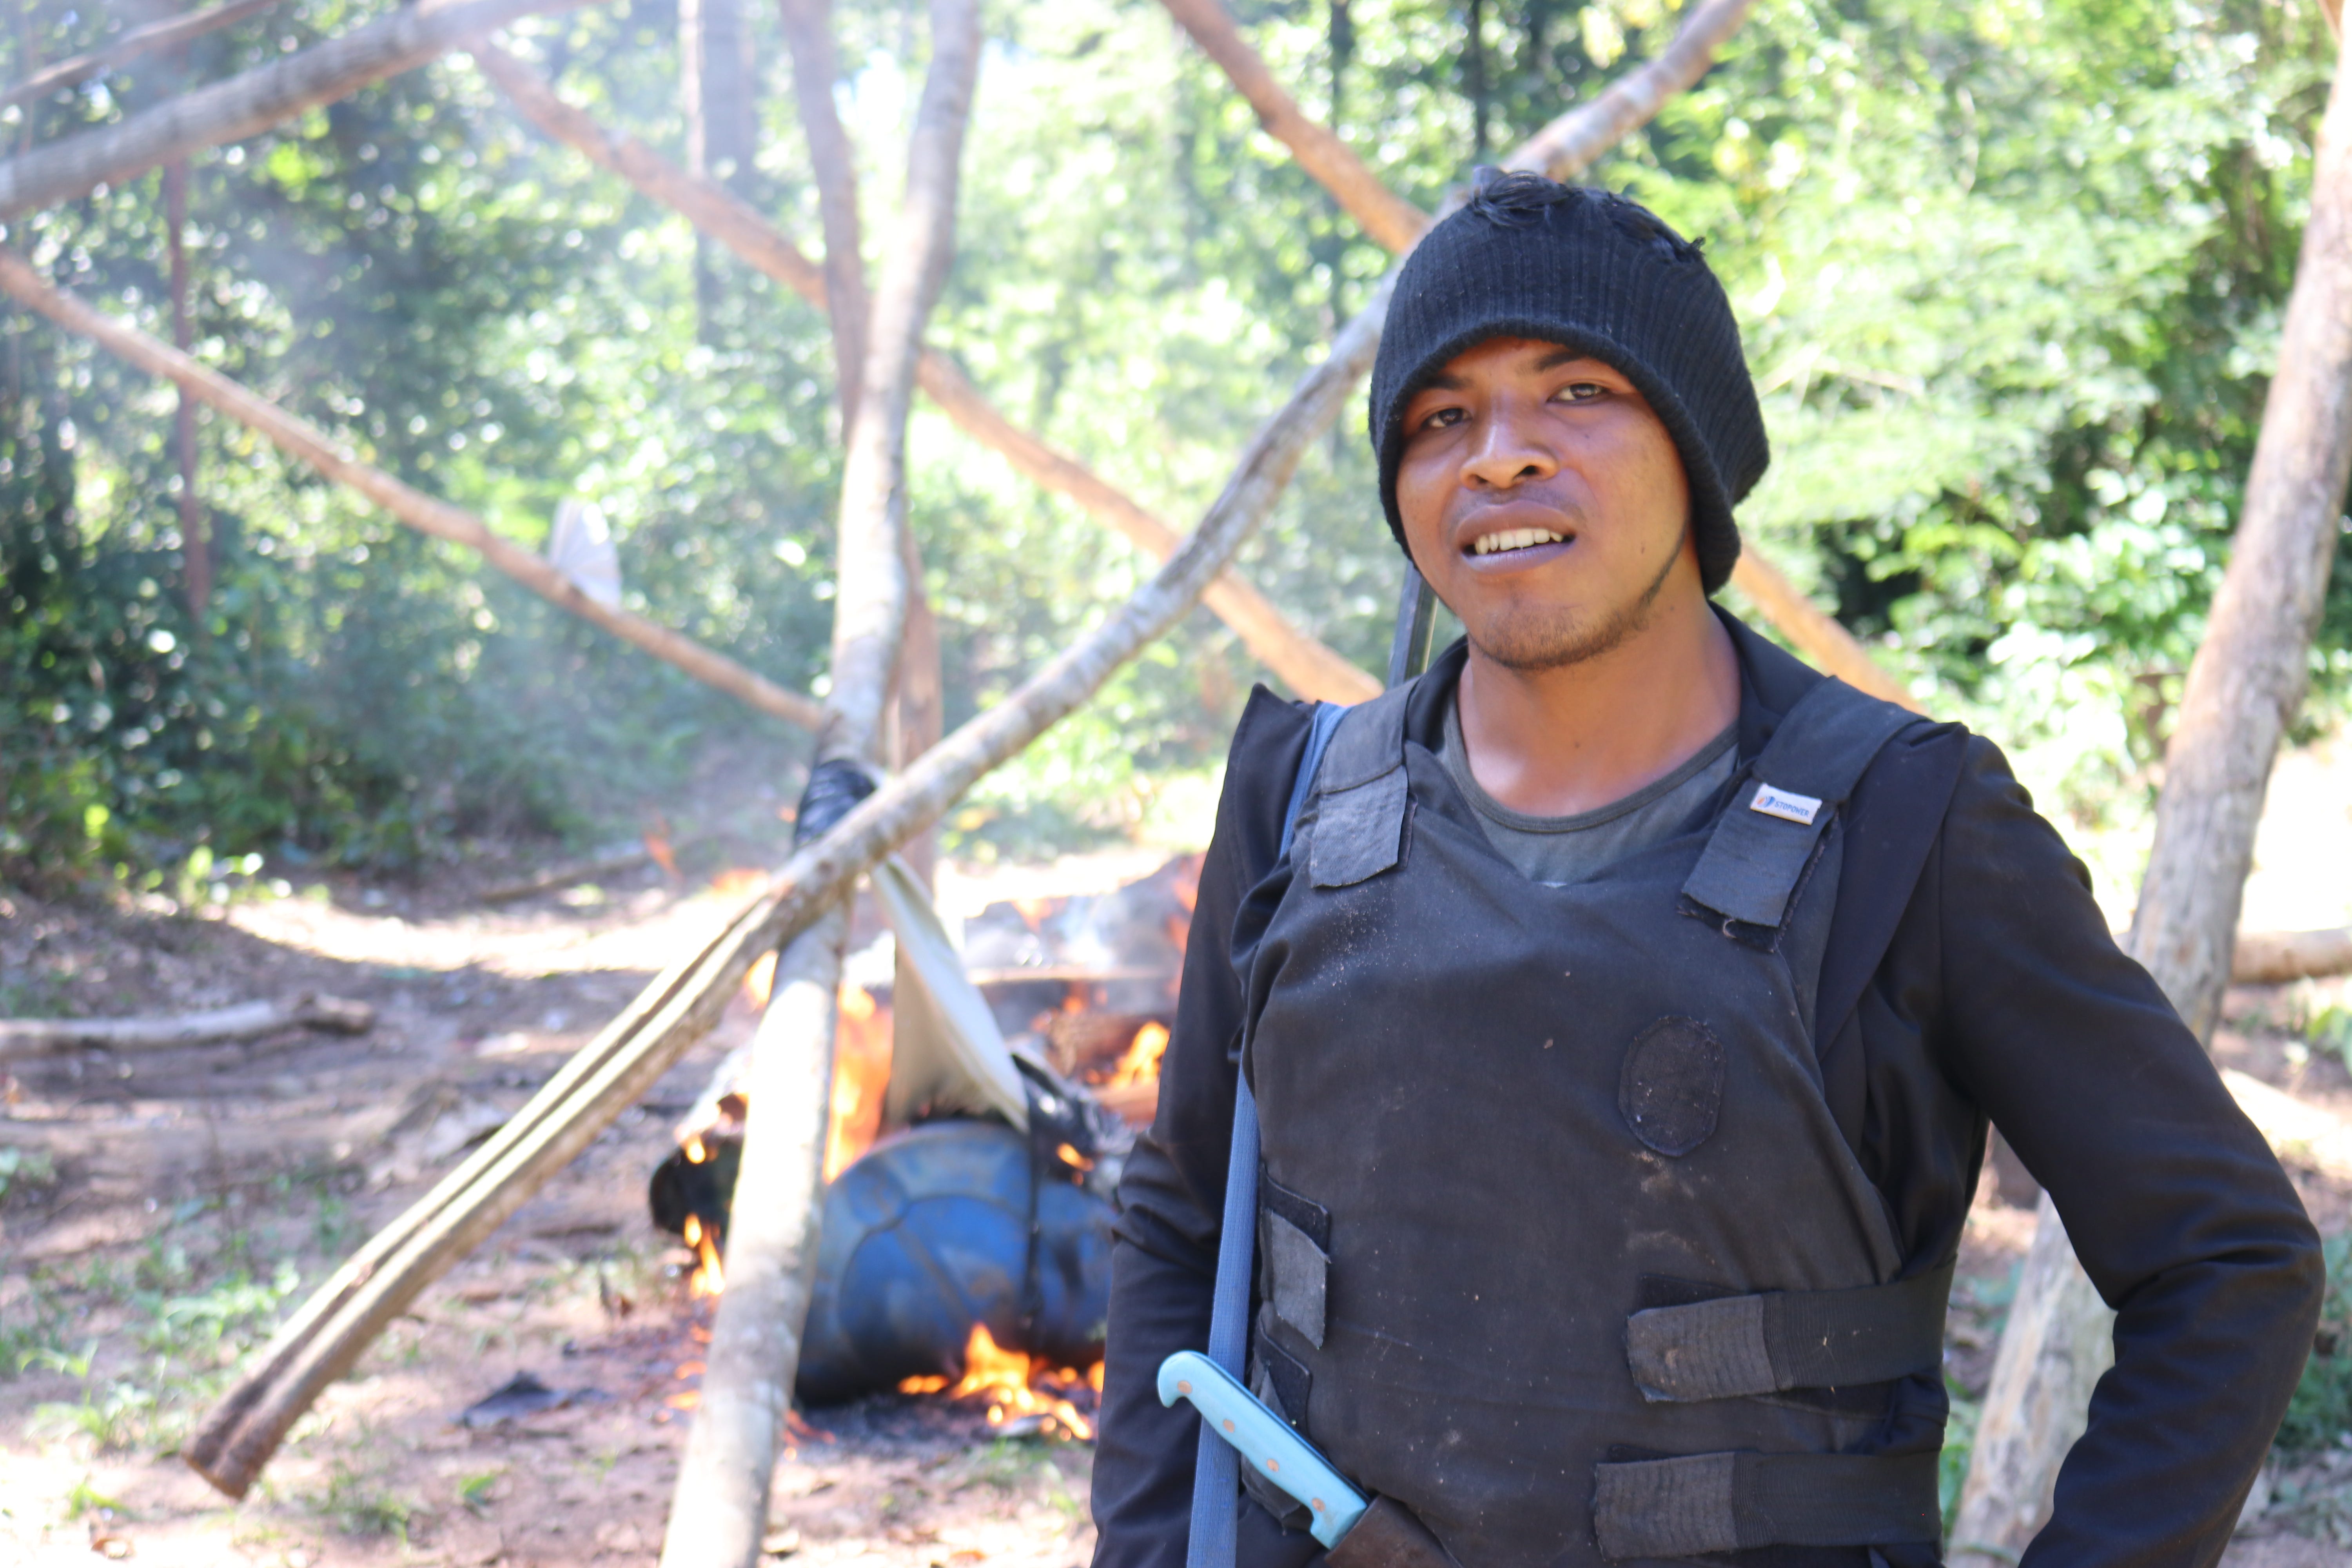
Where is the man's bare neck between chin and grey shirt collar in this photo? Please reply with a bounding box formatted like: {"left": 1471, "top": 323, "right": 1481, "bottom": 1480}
{"left": 1456, "top": 595, "right": 1740, "bottom": 816}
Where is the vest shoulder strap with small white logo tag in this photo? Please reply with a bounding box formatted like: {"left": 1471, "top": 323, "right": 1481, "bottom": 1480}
{"left": 1682, "top": 677, "right": 1924, "bottom": 926}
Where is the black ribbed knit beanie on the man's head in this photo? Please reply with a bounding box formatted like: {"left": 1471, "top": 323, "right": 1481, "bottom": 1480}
{"left": 1371, "top": 169, "right": 1771, "bottom": 592}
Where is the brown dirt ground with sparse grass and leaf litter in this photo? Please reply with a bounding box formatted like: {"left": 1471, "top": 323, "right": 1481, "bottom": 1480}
{"left": 14, "top": 846, "right": 2352, "bottom": 1568}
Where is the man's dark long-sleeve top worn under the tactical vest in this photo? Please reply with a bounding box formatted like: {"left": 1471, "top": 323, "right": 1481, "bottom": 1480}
{"left": 1094, "top": 618, "right": 2321, "bottom": 1568}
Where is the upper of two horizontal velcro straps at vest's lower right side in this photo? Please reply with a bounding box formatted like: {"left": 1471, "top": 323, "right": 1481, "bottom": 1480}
{"left": 1625, "top": 1267, "right": 1952, "bottom": 1401}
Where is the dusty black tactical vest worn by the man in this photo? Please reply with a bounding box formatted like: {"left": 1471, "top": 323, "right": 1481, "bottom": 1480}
{"left": 1237, "top": 679, "right": 1950, "bottom": 1568}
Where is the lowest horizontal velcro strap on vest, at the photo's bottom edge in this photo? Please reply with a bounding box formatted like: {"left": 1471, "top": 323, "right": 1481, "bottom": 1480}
{"left": 1592, "top": 1453, "right": 1943, "bottom": 1561}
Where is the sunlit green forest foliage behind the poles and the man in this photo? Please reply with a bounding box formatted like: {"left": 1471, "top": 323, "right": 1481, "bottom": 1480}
{"left": 0, "top": 0, "right": 2352, "bottom": 917}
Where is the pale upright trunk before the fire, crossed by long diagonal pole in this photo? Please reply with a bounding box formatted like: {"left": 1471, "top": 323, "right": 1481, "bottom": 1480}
{"left": 661, "top": 0, "right": 981, "bottom": 1568}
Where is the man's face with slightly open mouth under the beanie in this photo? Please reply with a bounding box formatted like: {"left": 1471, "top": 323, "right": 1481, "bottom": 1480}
{"left": 1397, "top": 339, "right": 1705, "bottom": 670}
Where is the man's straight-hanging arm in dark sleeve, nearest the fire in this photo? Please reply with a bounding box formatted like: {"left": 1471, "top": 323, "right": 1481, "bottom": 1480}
{"left": 1094, "top": 686, "right": 1308, "bottom": 1568}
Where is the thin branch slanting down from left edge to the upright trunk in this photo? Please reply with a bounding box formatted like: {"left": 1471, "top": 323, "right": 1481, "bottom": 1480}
{"left": 0, "top": 249, "right": 823, "bottom": 729}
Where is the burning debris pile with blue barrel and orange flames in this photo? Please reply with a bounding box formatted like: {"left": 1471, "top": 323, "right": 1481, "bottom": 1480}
{"left": 649, "top": 858, "right": 1200, "bottom": 1439}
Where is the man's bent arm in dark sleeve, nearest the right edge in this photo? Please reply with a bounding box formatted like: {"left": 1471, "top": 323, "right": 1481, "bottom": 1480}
{"left": 1938, "top": 740, "right": 2321, "bottom": 1568}
